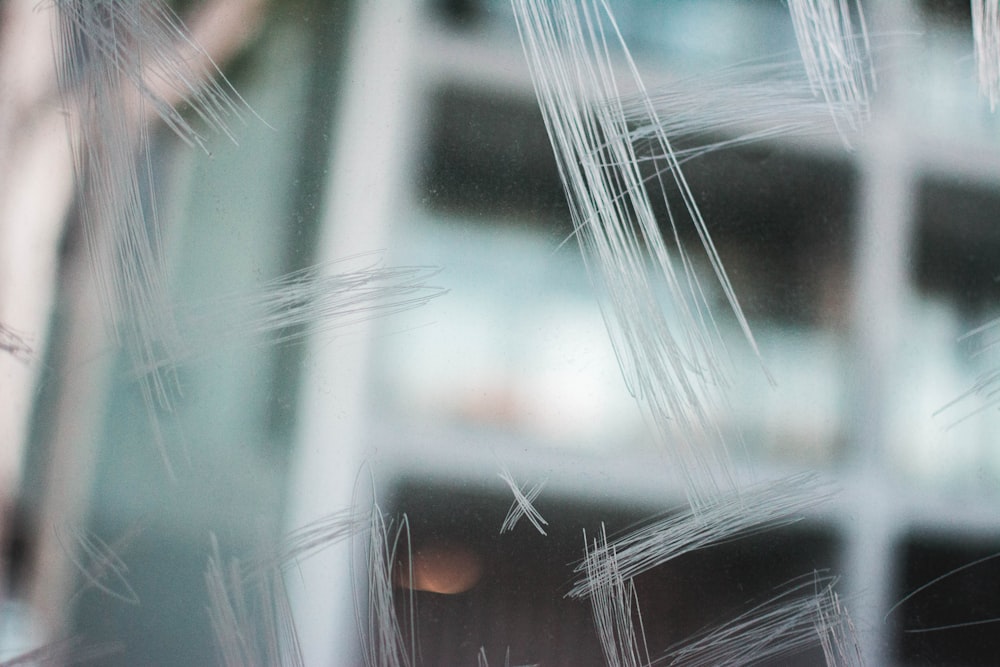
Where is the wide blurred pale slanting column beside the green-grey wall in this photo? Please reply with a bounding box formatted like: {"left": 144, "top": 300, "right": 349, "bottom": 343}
{"left": 287, "top": 0, "right": 424, "bottom": 665}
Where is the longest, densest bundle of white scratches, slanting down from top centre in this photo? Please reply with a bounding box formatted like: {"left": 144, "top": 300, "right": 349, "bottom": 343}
{"left": 512, "top": 0, "right": 760, "bottom": 504}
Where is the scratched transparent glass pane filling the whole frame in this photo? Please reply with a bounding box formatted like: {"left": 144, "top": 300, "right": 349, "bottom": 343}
{"left": 0, "top": 0, "right": 1000, "bottom": 665}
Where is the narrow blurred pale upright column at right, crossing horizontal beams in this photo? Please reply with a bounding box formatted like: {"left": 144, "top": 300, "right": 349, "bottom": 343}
{"left": 842, "top": 0, "right": 917, "bottom": 665}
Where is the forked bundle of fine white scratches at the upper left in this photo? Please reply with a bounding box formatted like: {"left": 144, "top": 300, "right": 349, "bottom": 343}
{"left": 52, "top": 0, "right": 258, "bottom": 471}
